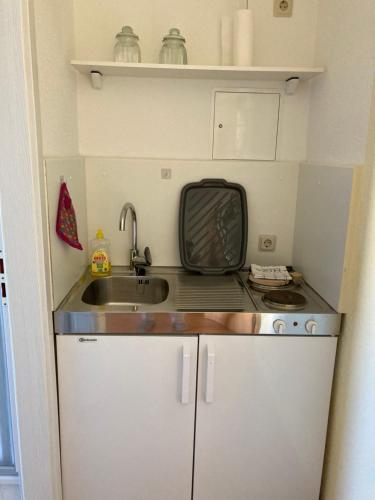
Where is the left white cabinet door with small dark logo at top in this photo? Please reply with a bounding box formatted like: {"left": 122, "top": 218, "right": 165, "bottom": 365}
{"left": 57, "top": 336, "right": 197, "bottom": 500}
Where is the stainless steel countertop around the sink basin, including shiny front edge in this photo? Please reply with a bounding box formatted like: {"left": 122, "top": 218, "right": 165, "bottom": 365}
{"left": 54, "top": 267, "right": 341, "bottom": 336}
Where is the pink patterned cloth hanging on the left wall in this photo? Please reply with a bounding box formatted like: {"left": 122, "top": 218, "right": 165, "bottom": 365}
{"left": 56, "top": 182, "right": 83, "bottom": 250}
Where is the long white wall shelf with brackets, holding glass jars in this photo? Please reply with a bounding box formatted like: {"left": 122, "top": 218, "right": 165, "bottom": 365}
{"left": 71, "top": 61, "right": 324, "bottom": 94}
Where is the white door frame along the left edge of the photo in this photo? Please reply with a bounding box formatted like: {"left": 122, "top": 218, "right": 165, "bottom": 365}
{"left": 0, "top": 0, "right": 61, "bottom": 500}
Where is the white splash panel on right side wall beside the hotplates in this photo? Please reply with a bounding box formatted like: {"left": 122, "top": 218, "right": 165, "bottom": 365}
{"left": 293, "top": 164, "right": 356, "bottom": 312}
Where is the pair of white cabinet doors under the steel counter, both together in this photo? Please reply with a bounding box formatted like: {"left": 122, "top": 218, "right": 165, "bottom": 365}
{"left": 57, "top": 335, "right": 336, "bottom": 500}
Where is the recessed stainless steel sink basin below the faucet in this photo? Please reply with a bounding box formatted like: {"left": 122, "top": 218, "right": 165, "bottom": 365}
{"left": 82, "top": 276, "right": 169, "bottom": 306}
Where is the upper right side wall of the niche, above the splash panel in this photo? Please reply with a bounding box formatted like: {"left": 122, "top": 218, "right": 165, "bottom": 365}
{"left": 307, "top": 0, "right": 375, "bottom": 164}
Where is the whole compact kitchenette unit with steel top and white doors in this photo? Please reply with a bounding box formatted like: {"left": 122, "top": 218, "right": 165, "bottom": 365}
{"left": 55, "top": 268, "right": 340, "bottom": 500}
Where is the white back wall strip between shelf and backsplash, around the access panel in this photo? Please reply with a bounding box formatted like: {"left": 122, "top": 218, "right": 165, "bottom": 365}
{"left": 78, "top": 75, "right": 309, "bottom": 160}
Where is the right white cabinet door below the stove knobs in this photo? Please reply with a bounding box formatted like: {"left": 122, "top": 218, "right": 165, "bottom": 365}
{"left": 194, "top": 336, "right": 336, "bottom": 500}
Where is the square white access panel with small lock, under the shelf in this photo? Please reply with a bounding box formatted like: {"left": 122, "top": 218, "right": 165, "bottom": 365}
{"left": 212, "top": 91, "right": 280, "bottom": 160}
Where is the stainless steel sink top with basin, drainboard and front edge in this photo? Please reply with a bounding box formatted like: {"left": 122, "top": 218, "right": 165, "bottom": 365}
{"left": 54, "top": 266, "right": 340, "bottom": 336}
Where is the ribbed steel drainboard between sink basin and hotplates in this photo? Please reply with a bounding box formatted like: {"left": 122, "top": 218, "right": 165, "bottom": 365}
{"left": 175, "top": 276, "right": 245, "bottom": 311}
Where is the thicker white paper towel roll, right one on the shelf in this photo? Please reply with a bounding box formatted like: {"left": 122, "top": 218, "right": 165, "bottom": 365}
{"left": 233, "top": 9, "right": 254, "bottom": 66}
